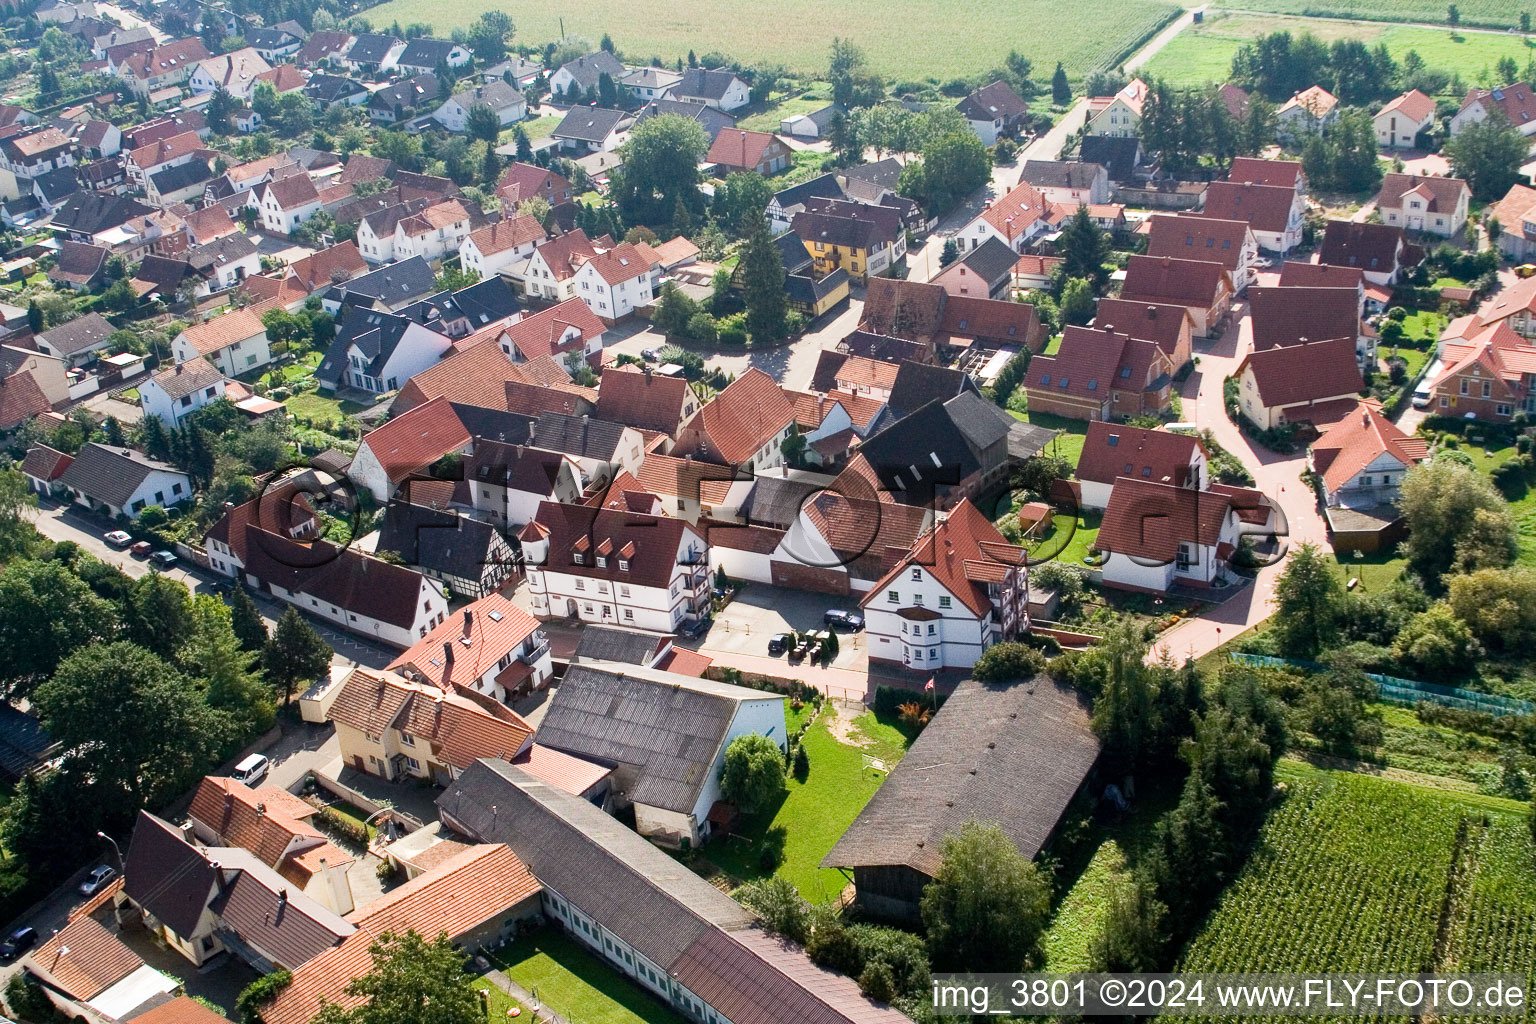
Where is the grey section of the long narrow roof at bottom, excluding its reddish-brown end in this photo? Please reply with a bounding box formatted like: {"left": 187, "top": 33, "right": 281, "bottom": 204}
{"left": 438, "top": 761, "right": 756, "bottom": 970}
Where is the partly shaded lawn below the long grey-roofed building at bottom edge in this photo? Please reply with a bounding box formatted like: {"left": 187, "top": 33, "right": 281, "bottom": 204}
{"left": 487, "top": 927, "right": 684, "bottom": 1024}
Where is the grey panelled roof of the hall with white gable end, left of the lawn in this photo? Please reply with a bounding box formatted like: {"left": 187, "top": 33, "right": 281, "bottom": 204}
{"left": 539, "top": 663, "right": 783, "bottom": 814}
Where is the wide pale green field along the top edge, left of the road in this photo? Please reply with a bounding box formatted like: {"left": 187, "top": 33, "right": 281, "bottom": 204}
{"left": 364, "top": 0, "right": 1177, "bottom": 81}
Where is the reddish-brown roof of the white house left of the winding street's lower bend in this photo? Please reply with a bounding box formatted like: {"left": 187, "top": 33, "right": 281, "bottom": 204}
{"left": 1098, "top": 476, "right": 1233, "bottom": 563}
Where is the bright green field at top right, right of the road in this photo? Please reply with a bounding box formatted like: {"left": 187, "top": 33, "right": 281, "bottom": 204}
{"left": 1143, "top": 11, "right": 1536, "bottom": 86}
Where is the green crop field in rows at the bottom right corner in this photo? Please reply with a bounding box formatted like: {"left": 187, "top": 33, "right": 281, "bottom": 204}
{"left": 1161, "top": 761, "right": 1536, "bottom": 1019}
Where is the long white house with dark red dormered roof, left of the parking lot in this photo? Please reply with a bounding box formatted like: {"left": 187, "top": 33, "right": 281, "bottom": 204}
{"left": 518, "top": 502, "right": 710, "bottom": 633}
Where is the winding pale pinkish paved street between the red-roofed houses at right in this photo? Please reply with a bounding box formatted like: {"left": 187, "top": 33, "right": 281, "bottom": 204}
{"left": 1147, "top": 302, "right": 1327, "bottom": 660}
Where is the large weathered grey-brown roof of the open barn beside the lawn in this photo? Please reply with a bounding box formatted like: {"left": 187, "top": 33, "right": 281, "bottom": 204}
{"left": 822, "top": 676, "right": 1098, "bottom": 877}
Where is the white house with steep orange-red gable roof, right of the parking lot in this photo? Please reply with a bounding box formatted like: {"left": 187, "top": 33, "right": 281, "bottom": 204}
{"left": 859, "top": 499, "right": 1029, "bottom": 672}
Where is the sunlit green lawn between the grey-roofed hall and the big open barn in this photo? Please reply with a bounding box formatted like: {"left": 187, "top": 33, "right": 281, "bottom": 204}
{"left": 703, "top": 709, "right": 909, "bottom": 903}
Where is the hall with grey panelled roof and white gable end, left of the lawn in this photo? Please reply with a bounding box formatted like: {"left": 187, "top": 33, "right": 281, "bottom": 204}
{"left": 539, "top": 660, "right": 790, "bottom": 847}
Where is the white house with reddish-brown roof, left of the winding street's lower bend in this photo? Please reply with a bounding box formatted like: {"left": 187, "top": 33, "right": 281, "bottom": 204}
{"left": 1097, "top": 477, "right": 1241, "bottom": 594}
